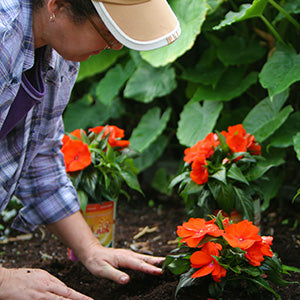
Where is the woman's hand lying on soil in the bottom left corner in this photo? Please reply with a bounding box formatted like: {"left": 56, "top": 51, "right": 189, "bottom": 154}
{"left": 0, "top": 268, "right": 92, "bottom": 300}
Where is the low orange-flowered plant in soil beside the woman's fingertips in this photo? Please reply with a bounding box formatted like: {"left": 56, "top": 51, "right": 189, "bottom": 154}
{"left": 163, "top": 212, "right": 291, "bottom": 299}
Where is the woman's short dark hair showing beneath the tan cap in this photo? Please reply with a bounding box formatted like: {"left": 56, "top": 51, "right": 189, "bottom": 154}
{"left": 32, "top": 0, "right": 97, "bottom": 22}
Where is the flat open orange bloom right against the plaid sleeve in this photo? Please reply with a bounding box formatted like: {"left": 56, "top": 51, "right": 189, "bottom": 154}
{"left": 61, "top": 139, "right": 92, "bottom": 172}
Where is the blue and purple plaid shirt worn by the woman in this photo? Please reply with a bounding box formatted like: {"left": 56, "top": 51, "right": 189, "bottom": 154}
{"left": 0, "top": 0, "right": 79, "bottom": 232}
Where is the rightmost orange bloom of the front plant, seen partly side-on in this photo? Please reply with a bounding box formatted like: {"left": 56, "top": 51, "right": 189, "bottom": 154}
{"left": 245, "top": 236, "right": 273, "bottom": 266}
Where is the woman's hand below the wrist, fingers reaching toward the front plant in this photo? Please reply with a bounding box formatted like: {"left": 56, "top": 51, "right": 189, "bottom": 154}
{"left": 80, "top": 241, "right": 164, "bottom": 284}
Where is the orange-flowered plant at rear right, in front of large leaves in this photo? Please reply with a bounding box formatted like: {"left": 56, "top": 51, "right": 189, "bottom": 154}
{"left": 170, "top": 124, "right": 264, "bottom": 220}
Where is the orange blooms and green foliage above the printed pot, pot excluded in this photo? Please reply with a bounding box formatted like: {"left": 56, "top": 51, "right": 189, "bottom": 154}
{"left": 61, "top": 125, "right": 142, "bottom": 211}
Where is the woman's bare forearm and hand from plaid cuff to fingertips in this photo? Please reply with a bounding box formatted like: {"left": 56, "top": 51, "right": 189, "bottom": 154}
{"left": 47, "top": 212, "right": 164, "bottom": 284}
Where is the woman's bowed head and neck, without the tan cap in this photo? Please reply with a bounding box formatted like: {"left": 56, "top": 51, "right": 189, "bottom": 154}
{"left": 33, "top": 0, "right": 122, "bottom": 61}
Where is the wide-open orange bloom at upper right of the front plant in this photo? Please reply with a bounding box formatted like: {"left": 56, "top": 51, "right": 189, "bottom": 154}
{"left": 223, "top": 220, "right": 262, "bottom": 250}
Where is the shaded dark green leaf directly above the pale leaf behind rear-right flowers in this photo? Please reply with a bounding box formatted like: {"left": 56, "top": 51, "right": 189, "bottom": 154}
{"left": 191, "top": 68, "right": 257, "bottom": 102}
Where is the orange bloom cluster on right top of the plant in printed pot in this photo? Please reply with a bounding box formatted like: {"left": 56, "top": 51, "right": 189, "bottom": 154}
{"left": 89, "top": 125, "right": 130, "bottom": 149}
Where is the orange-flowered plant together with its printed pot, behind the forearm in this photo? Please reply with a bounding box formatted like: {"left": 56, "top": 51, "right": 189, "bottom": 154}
{"left": 61, "top": 125, "right": 143, "bottom": 258}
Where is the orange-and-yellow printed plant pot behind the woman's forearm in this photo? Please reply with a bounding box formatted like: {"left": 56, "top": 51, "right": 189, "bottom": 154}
{"left": 68, "top": 201, "right": 116, "bottom": 261}
